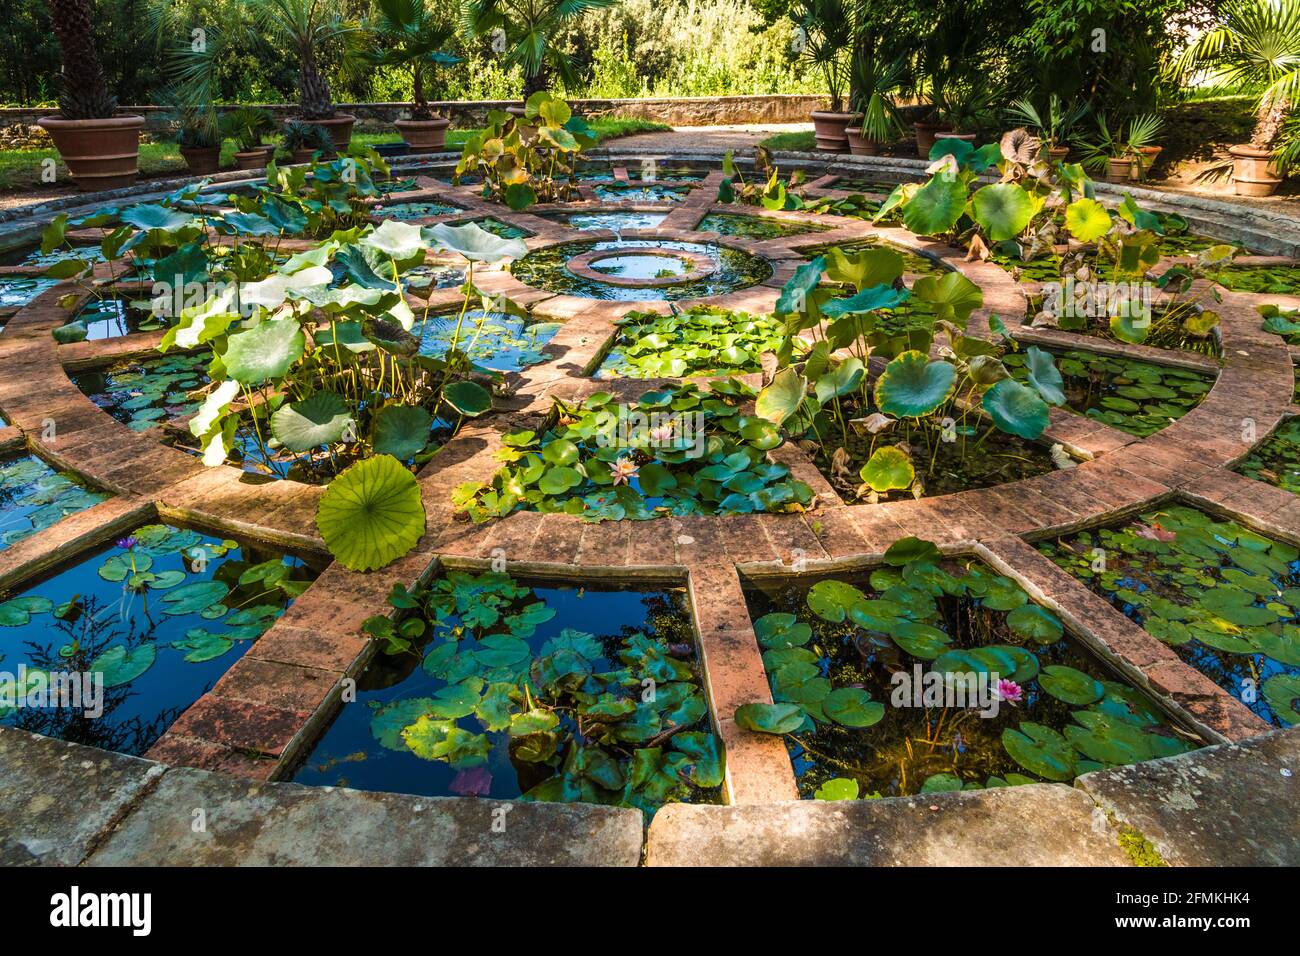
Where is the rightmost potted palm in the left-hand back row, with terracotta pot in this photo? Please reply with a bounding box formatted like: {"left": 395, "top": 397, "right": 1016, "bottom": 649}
{"left": 358, "top": 0, "right": 460, "bottom": 152}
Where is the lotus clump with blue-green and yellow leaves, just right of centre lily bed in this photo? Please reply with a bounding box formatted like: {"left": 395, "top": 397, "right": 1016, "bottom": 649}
{"left": 755, "top": 247, "right": 1065, "bottom": 501}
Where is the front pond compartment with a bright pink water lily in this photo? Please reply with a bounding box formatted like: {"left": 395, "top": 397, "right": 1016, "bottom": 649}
{"left": 737, "top": 561, "right": 1196, "bottom": 799}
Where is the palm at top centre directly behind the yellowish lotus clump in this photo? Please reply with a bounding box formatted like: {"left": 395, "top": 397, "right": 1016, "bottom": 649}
{"left": 460, "top": 0, "right": 618, "bottom": 100}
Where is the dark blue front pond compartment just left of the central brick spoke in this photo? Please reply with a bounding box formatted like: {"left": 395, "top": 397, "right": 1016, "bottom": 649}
{"left": 294, "top": 571, "right": 722, "bottom": 810}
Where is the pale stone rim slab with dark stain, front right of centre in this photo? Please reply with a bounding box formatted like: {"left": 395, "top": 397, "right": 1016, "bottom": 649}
{"left": 646, "top": 784, "right": 1128, "bottom": 866}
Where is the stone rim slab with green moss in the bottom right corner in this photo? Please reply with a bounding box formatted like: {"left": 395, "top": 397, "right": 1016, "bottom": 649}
{"left": 1076, "top": 727, "right": 1300, "bottom": 866}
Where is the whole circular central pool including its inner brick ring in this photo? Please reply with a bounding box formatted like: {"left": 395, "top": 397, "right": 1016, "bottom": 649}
{"left": 511, "top": 239, "right": 772, "bottom": 302}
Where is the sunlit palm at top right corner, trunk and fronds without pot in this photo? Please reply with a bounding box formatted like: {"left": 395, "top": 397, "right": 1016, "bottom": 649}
{"left": 1174, "top": 0, "right": 1300, "bottom": 150}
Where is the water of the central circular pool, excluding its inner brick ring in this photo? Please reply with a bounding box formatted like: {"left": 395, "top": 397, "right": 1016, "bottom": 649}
{"left": 511, "top": 239, "right": 772, "bottom": 302}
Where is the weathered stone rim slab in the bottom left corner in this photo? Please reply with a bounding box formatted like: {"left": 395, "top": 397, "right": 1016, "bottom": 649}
{"left": 0, "top": 727, "right": 163, "bottom": 866}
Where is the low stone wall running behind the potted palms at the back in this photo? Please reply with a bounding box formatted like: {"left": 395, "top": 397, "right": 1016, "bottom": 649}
{"left": 0, "top": 95, "right": 826, "bottom": 138}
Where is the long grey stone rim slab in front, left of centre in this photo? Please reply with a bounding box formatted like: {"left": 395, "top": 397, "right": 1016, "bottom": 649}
{"left": 88, "top": 770, "right": 642, "bottom": 866}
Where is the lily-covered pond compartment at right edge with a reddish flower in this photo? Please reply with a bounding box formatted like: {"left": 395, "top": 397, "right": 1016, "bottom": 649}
{"left": 1039, "top": 505, "right": 1300, "bottom": 726}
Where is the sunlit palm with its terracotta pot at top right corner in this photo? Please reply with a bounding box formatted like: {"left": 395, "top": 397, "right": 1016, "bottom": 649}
{"left": 1174, "top": 0, "right": 1300, "bottom": 196}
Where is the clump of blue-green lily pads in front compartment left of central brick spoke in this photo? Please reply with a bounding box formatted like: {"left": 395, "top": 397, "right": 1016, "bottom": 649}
{"left": 353, "top": 571, "right": 723, "bottom": 813}
